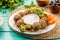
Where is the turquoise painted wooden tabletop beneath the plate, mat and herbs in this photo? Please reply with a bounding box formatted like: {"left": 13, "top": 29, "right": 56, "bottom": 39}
{"left": 0, "top": 0, "right": 60, "bottom": 40}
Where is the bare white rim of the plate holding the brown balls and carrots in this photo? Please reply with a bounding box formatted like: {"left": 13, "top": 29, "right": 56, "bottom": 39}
{"left": 8, "top": 11, "right": 56, "bottom": 35}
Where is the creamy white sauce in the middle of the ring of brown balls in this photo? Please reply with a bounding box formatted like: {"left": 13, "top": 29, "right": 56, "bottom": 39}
{"left": 22, "top": 14, "right": 39, "bottom": 25}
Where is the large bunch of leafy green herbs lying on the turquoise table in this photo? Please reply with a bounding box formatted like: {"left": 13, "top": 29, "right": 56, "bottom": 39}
{"left": 0, "top": 0, "right": 24, "bottom": 9}
